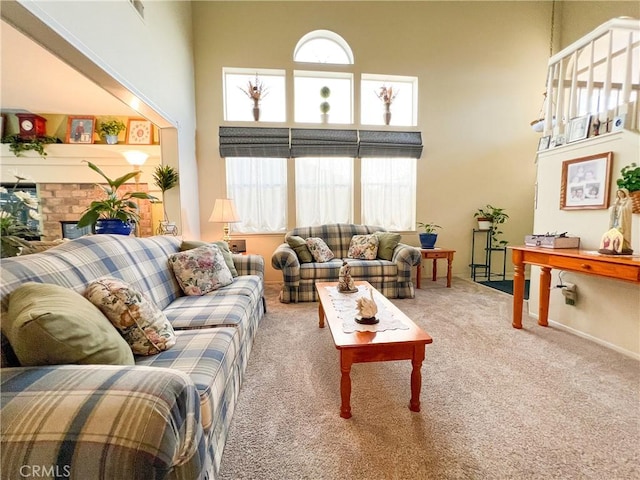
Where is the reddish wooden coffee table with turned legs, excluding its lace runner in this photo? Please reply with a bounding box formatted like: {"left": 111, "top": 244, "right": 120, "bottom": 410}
{"left": 316, "top": 282, "right": 433, "bottom": 418}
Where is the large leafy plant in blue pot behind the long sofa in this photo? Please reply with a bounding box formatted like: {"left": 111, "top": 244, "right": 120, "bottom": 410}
{"left": 77, "top": 160, "right": 158, "bottom": 235}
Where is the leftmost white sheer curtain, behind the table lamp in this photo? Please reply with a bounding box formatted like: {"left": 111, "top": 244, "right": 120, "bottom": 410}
{"left": 226, "top": 157, "right": 287, "bottom": 233}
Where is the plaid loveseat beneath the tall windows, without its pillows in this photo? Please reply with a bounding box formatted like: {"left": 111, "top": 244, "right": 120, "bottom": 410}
{"left": 271, "top": 223, "right": 421, "bottom": 303}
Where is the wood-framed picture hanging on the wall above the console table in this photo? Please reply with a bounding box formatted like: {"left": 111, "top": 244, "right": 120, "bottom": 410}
{"left": 560, "top": 152, "right": 613, "bottom": 210}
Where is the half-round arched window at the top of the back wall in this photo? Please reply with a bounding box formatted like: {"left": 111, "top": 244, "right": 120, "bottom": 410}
{"left": 293, "top": 30, "right": 353, "bottom": 65}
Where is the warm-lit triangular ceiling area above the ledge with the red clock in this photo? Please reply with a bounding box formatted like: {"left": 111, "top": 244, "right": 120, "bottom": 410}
{"left": 0, "top": 21, "right": 139, "bottom": 116}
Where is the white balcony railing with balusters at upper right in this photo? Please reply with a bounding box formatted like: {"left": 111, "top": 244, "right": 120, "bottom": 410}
{"left": 543, "top": 17, "right": 640, "bottom": 137}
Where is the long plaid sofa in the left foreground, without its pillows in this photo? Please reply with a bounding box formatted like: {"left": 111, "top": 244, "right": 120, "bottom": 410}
{"left": 0, "top": 235, "right": 265, "bottom": 480}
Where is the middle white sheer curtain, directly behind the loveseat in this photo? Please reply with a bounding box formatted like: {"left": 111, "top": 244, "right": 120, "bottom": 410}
{"left": 296, "top": 157, "right": 353, "bottom": 226}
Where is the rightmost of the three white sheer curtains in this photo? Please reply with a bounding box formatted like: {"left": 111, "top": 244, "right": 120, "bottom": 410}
{"left": 362, "top": 158, "right": 416, "bottom": 230}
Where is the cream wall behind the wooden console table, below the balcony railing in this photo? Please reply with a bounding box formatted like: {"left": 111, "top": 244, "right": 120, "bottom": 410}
{"left": 529, "top": 132, "right": 640, "bottom": 358}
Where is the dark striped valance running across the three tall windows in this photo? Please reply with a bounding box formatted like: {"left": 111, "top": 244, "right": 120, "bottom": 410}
{"left": 220, "top": 127, "right": 422, "bottom": 158}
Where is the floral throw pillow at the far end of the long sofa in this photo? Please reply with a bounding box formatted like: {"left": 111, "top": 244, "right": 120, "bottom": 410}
{"left": 169, "top": 245, "right": 233, "bottom": 295}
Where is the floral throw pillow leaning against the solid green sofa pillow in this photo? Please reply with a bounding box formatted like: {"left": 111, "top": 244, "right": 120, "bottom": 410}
{"left": 84, "top": 277, "right": 176, "bottom": 355}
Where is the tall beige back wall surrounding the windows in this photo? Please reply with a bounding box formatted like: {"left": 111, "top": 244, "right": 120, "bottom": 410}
{"left": 193, "top": 2, "right": 550, "bottom": 281}
